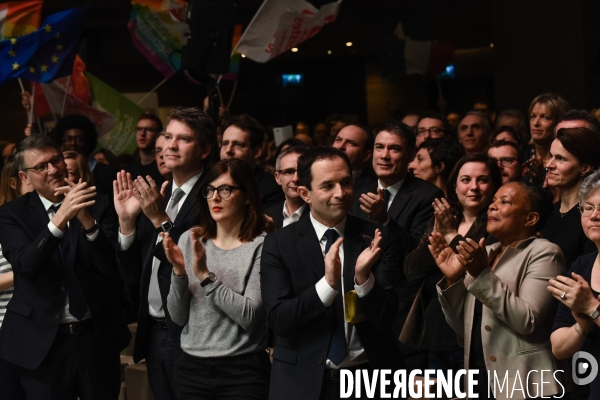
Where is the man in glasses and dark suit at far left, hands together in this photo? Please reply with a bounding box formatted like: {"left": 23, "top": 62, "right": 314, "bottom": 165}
{"left": 0, "top": 135, "right": 131, "bottom": 400}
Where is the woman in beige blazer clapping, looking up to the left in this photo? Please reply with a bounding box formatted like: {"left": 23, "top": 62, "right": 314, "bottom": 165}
{"left": 429, "top": 182, "right": 566, "bottom": 399}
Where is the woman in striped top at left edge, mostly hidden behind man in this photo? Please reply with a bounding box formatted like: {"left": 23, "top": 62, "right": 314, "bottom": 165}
{"left": 0, "top": 156, "right": 33, "bottom": 400}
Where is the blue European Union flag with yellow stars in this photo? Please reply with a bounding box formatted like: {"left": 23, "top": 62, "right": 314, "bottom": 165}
{"left": 0, "top": 7, "right": 87, "bottom": 84}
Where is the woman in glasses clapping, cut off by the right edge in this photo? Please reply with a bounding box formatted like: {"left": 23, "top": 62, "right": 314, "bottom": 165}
{"left": 548, "top": 170, "right": 600, "bottom": 399}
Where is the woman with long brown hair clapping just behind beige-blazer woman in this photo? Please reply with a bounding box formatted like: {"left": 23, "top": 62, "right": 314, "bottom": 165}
{"left": 400, "top": 153, "right": 502, "bottom": 382}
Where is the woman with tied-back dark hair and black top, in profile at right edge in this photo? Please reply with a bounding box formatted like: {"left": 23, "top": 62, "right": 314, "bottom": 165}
{"left": 541, "top": 128, "right": 600, "bottom": 266}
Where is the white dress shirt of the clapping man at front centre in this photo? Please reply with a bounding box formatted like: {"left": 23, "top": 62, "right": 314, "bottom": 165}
{"left": 310, "top": 213, "right": 375, "bottom": 369}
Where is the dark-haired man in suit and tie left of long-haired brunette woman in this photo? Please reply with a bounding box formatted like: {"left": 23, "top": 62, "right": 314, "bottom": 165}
{"left": 360, "top": 121, "right": 444, "bottom": 369}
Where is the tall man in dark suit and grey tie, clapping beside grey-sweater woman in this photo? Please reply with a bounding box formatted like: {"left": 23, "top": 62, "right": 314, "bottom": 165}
{"left": 115, "top": 108, "right": 216, "bottom": 400}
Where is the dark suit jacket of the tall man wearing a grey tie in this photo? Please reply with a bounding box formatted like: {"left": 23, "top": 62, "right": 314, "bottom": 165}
{"left": 117, "top": 176, "right": 202, "bottom": 362}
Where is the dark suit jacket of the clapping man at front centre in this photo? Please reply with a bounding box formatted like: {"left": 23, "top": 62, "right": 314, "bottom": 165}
{"left": 261, "top": 216, "right": 403, "bottom": 400}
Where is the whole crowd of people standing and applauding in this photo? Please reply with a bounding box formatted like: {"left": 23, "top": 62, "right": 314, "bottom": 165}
{"left": 0, "top": 93, "right": 600, "bottom": 400}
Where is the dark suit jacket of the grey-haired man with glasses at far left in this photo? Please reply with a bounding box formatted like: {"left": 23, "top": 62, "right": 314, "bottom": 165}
{"left": 0, "top": 192, "right": 131, "bottom": 369}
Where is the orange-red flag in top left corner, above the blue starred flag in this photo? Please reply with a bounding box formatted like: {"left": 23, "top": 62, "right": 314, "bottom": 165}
{"left": 0, "top": 0, "right": 42, "bottom": 39}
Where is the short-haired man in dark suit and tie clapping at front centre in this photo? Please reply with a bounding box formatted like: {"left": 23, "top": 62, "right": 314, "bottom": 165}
{"left": 261, "top": 147, "right": 403, "bottom": 400}
